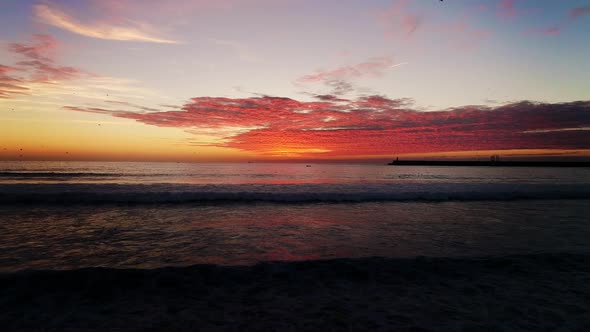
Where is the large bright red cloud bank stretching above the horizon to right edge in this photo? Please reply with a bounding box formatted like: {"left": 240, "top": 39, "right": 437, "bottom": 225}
{"left": 67, "top": 96, "right": 590, "bottom": 157}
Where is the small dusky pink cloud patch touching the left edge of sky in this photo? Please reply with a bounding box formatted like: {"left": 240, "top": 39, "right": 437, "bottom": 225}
{"left": 0, "top": 35, "right": 86, "bottom": 98}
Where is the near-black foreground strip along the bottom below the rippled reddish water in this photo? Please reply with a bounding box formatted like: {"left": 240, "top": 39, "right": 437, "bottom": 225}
{"left": 0, "top": 254, "right": 590, "bottom": 331}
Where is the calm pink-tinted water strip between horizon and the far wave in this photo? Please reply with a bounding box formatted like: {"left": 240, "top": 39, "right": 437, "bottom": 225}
{"left": 0, "top": 162, "right": 590, "bottom": 184}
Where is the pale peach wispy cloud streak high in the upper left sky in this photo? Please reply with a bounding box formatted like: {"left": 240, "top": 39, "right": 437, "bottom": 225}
{"left": 33, "top": 4, "right": 178, "bottom": 44}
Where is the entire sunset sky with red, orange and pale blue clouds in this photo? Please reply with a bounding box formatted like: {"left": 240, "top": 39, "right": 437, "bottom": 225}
{"left": 0, "top": 0, "right": 590, "bottom": 162}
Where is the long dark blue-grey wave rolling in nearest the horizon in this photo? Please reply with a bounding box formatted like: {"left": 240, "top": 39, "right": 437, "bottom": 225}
{"left": 0, "top": 183, "right": 590, "bottom": 205}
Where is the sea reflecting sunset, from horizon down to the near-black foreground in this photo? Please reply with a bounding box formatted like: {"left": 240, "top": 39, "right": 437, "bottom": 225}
{"left": 0, "top": 161, "right": 590, "bottom": 272}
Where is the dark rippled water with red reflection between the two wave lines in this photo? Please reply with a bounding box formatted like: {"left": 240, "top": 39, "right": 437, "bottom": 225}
{"left": 0, "top": 200, "right": 590, "bottom": 271}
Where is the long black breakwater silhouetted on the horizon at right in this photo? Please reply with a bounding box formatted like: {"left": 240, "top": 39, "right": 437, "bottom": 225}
{"left": 387, "top": 160, "right": 590, "bottom": 167}
